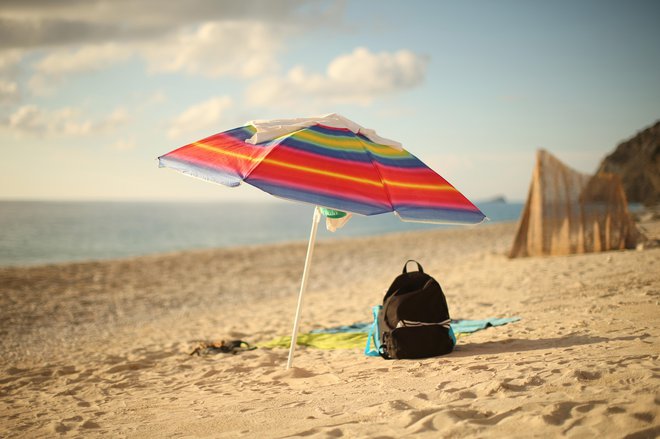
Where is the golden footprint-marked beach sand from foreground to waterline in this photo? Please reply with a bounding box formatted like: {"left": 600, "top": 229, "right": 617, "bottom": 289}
{"left": 0, "top": 222, "right": 660, "bottom": 438}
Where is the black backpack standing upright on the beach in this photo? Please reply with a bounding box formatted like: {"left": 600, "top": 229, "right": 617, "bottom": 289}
{"left": 378, "top": 260, "right": 456, "bottom": 358}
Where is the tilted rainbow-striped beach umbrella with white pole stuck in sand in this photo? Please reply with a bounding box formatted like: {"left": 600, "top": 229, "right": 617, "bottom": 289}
{"left": 158, "top": 114, "right": 485, "bottom": 368}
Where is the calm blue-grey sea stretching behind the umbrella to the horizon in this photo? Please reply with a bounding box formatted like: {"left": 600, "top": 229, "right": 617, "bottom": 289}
{"left": 0, "top": 201, "right": 523, "bottom": 266}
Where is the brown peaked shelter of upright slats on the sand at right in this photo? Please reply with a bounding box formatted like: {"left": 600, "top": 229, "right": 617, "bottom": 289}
{"left": 509, "top": 150, "right": 641, "bottom": 258}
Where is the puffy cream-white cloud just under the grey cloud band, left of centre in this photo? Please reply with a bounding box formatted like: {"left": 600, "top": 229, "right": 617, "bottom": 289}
{"left": 142, "top": 21, "right": 284, "bottom": 78}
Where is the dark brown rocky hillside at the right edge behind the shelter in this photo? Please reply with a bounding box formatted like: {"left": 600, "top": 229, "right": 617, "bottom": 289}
{"left": 598, "top": 121, "right": 660, "bottom": 205}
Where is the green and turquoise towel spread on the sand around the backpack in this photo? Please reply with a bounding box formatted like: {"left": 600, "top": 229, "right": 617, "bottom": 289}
{"left": 257, "top": 317, "right": 520, "bottom": 356}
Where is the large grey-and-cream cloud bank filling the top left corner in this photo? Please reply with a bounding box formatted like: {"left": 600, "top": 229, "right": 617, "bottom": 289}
{"left": 0, "top": 0, "right": 344, "bottom": 95}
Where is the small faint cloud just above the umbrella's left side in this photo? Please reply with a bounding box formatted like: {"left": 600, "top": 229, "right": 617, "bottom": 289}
{"left": 168, "top": 96, "right": 234, "bottom": 138}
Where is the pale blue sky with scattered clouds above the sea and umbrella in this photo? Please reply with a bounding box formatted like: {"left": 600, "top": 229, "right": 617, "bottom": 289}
{"left": 0, "top": 0, "right": 660, "bottom": 201}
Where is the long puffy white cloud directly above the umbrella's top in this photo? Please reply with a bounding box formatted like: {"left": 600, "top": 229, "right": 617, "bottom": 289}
{"left": 247, "top": 47, "right": 427, "bottom": 108}
